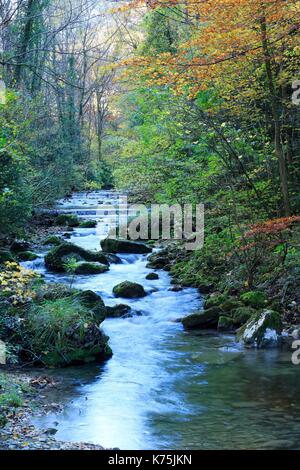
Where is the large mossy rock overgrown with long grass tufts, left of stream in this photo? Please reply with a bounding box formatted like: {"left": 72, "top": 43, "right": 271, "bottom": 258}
{"left": 18, "top": 291, "right": 111, "bottom": 367}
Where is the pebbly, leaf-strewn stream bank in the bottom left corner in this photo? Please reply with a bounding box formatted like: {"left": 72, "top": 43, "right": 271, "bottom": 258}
{"left": 0, "top": 370, "right": 104, "bottom": 451}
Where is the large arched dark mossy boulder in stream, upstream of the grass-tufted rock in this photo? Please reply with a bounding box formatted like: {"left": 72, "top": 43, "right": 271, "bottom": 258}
{"left": 45, "top": 243, "right": 109, "bottom": 272}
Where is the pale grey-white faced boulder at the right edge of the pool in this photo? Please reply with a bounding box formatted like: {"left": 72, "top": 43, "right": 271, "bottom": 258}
{"left": 238, "top": 310, "right": 282, "bottom": 348}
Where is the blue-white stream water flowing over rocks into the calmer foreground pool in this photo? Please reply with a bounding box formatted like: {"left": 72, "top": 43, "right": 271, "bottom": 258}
{"left": 24, "top": 191, "right": 300, "bottom": 450}
